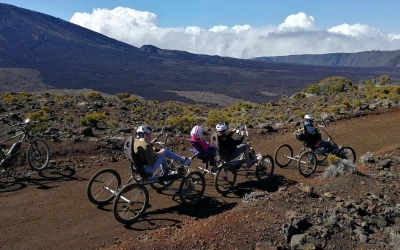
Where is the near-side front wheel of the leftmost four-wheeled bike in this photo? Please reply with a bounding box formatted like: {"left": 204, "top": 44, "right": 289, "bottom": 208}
{"left": 178, "top": 171, "right": 206, "bottom": 206}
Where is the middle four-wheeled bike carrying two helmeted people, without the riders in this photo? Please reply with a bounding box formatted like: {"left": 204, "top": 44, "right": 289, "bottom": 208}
{"left": 197, "top": 123, "right": 274, "bottom": 195}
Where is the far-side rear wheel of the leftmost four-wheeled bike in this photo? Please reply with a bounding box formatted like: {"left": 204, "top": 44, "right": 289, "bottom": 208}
{"left": 86, "top": 168, "right": 121, "bottom": 206}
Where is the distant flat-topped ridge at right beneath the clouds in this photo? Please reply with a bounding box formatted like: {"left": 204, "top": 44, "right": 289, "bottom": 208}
{"left": 253, "top": 50, "right": 400, "bottom": 67}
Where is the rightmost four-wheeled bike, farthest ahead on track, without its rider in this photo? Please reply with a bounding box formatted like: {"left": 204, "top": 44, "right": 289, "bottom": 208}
{"left": 275, "top": 120, "right": 356, "bottom": 177}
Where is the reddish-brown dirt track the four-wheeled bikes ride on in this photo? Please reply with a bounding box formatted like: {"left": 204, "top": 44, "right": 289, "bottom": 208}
{"left": 0, "top": 112, "right": 400, "bottom": 249}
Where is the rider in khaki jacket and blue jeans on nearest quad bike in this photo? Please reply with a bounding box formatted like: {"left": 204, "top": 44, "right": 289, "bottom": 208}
{"left": 132, "top": 125, "right": 192, "bottom": 175}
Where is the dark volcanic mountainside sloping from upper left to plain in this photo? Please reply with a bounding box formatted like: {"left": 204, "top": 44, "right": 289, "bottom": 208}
{"left": 0, "top": 4, "right": 400, "bottom": 102}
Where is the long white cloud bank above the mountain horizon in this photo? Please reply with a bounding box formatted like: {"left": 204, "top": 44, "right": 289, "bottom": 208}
{"left": 70, "top": 7, "right": 400, "bottom": 58}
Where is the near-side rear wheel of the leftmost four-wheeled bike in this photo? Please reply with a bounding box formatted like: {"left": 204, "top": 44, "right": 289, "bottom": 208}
{"left": 113, "top": 183, "right": 149, "bottom": 224}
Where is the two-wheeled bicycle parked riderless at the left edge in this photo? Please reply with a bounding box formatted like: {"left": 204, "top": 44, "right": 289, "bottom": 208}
{"left": 0, "top": 119, "right": 50, "bottom": 172}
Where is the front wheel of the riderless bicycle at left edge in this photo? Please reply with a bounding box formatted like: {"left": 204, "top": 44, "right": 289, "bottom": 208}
{"left": 27, "top": 139, "right": 50, "bottom": 171}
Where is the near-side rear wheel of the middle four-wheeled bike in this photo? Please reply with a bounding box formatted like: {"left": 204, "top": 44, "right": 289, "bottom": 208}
{"left": 214, "top": 166, "right": 237, "bottom": 195}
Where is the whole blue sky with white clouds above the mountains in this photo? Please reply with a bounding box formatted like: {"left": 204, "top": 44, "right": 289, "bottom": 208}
{"left": 0, "top": 0, "right": 400, "bottom": 59}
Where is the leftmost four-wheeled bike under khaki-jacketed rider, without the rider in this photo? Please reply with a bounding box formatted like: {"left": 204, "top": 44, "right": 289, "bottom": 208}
{"left": 87, "top": 133, "right": 205, "bottom": 224}
